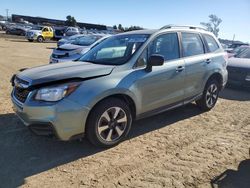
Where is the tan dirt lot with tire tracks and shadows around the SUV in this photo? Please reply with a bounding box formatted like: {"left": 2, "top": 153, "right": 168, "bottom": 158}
{"left": 0, "top": 35, "right": 250, "bottom": 188}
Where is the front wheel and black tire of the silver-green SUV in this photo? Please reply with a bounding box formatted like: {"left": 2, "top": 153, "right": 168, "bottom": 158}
{"left": 86, "top": 98, "right": 132, "bottom": 147}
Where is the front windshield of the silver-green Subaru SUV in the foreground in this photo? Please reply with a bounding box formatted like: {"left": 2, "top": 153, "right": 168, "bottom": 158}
{"left": 79, "top": 34, "right": 149, "bottom": 65}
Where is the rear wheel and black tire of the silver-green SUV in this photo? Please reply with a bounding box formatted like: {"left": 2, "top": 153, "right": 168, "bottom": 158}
{"left": 196, "top": 79, "right": 220, "bottom": 111}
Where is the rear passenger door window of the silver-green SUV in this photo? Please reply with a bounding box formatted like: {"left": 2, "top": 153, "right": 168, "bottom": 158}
{"left": 182, "top": 33, "right": 204, "bottom": 57}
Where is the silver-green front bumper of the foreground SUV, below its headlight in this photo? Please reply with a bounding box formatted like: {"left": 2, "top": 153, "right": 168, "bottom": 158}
{"left": 12, "top": 93, "right": 89, "bottom": 141}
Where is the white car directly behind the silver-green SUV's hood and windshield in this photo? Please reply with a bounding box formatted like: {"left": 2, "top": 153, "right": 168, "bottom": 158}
{"left": 49, "top": 35, "right": 110, "bottom": 64}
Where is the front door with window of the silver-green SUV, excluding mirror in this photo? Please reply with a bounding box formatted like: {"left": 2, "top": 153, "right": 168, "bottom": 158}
{"left": 135, "top": 33, "right": 185, "bottom": 113}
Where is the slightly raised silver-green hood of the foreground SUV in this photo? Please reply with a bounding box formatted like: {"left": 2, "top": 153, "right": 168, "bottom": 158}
{"left": 17, "top": 61, "right": 114, "bottom": 86}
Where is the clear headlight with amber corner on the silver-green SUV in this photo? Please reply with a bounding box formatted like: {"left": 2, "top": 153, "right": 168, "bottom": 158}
{"left": 35, "top": 83, "right": 80, "bottom": 102}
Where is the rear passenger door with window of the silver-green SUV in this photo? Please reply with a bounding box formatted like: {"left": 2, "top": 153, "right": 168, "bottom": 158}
{"left": 181, "top": 32, "right": 208, "bottom": 100}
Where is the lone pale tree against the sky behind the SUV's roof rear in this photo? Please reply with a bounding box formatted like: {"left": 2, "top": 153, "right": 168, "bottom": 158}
{"left": 200, "top": 14, "right": 222, "bottom": 37}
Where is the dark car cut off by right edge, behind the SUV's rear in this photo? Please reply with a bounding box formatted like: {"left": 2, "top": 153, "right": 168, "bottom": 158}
{"left": 227, "top": 47, "right": 250, "bottom": 88}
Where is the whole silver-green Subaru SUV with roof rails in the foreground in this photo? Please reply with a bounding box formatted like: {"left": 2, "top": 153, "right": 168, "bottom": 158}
{"left": 12, "top": 26, "right": 227, "bottom": 147}
